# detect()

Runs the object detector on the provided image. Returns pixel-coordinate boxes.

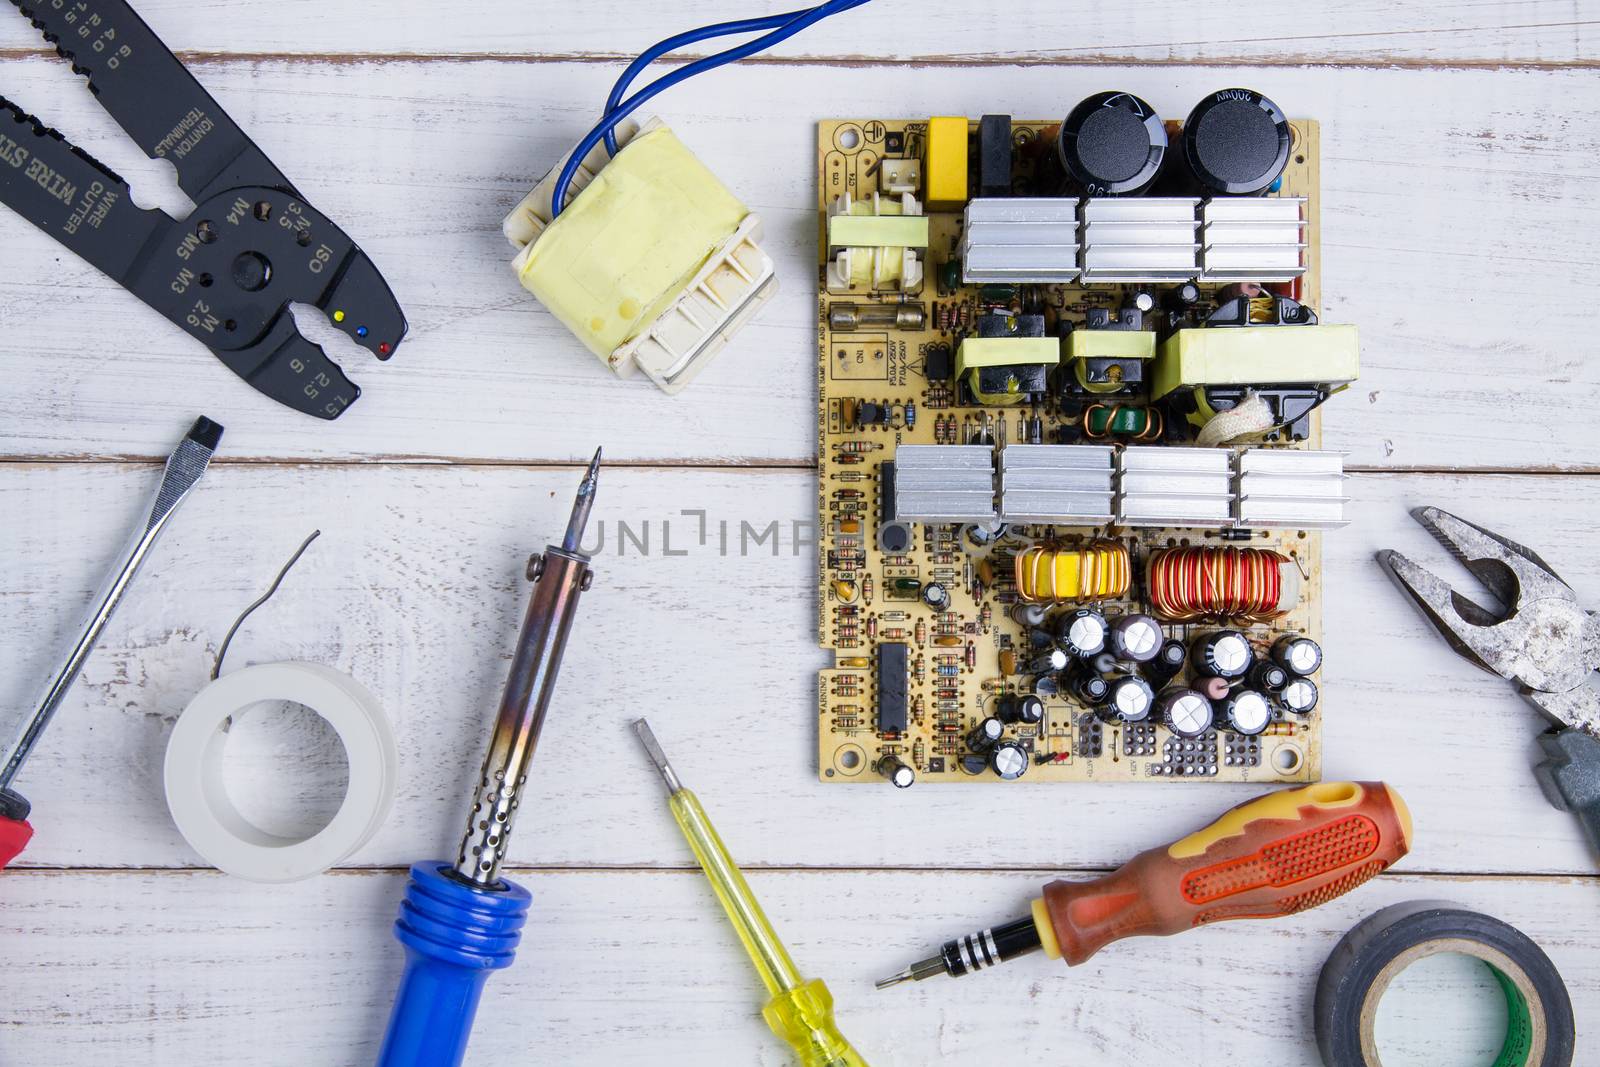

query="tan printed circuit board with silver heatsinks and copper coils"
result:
[818,103,1354,785]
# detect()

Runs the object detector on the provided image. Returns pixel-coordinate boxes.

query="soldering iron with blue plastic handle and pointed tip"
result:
[378,448,600,1067]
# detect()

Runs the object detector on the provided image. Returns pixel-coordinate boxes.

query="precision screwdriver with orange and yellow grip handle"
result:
[877,782,1411,989]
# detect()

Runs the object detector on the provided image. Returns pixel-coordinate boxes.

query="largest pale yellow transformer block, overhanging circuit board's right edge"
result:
[1152,323,1362,400]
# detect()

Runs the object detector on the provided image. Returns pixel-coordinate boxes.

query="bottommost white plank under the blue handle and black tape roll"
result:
[0,870,1600,1067]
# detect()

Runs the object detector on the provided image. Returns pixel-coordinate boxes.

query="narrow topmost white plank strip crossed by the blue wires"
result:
[0,0,1600,66]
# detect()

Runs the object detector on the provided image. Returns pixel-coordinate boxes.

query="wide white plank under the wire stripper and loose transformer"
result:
[0,59,1600,470]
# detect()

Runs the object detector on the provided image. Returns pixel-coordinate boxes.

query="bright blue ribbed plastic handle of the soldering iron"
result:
[378,859,533,1067]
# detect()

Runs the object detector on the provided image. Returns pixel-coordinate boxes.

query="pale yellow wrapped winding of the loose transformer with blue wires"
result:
[512,126,750,363]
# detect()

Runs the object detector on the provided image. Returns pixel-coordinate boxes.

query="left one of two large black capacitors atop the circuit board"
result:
[1053,93,1166,197]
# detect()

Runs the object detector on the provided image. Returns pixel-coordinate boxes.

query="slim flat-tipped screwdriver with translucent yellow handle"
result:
[634,718,867,1067]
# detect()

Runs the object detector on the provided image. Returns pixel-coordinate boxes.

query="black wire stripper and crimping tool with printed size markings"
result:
[0,0,406,419]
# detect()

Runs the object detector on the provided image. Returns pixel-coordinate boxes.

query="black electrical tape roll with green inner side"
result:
[1315,901,1576,1067]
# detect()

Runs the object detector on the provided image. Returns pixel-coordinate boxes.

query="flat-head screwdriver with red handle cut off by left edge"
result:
[0,416,222,867]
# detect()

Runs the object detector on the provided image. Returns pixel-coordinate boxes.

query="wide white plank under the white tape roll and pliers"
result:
[0,464,1600,873]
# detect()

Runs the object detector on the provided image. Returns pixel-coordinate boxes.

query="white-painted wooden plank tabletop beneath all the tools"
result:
[0,0,1600,1067]
